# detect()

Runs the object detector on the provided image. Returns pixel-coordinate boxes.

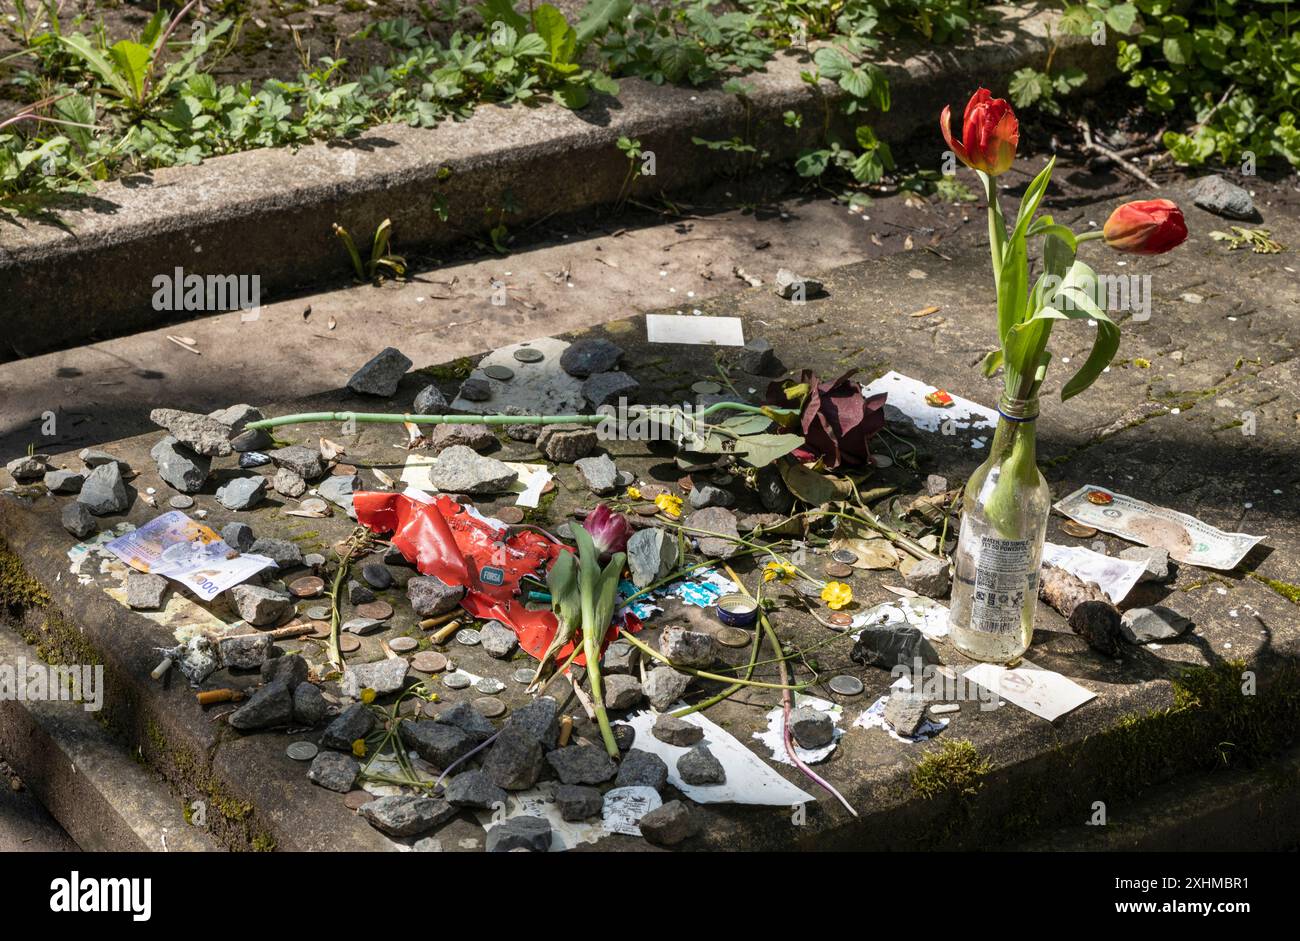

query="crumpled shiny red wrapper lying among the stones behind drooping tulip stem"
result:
[352,491,641,664]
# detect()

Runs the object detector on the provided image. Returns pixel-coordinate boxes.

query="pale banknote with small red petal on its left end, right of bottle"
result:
[1054,485,1264,569]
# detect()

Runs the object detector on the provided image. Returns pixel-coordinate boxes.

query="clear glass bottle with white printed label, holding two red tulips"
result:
[949,395,1052,663]
